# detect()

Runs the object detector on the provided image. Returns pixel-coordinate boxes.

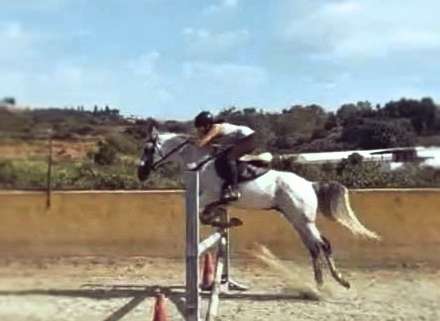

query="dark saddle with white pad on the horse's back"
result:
[215,153,273,183]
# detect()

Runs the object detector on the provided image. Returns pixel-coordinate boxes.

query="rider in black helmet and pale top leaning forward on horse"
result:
[194,111,256,201]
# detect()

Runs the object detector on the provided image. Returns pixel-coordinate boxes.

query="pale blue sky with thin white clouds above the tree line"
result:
[0,0,440,120]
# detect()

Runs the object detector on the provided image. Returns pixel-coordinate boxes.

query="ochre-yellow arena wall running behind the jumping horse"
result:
[0,189,440,266]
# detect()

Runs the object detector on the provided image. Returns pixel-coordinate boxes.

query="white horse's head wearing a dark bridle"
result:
[138,127,189,181]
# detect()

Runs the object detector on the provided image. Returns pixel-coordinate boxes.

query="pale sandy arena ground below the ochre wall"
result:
[0,257,440,321]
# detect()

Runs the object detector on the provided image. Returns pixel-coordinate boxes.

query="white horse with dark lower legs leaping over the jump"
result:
[138,129,379,288]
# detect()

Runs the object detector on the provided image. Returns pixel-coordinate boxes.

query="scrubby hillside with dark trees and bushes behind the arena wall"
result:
[0,98,440,189]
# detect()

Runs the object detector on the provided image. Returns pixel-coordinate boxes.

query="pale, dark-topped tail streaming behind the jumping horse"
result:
[313,182,380,240]
